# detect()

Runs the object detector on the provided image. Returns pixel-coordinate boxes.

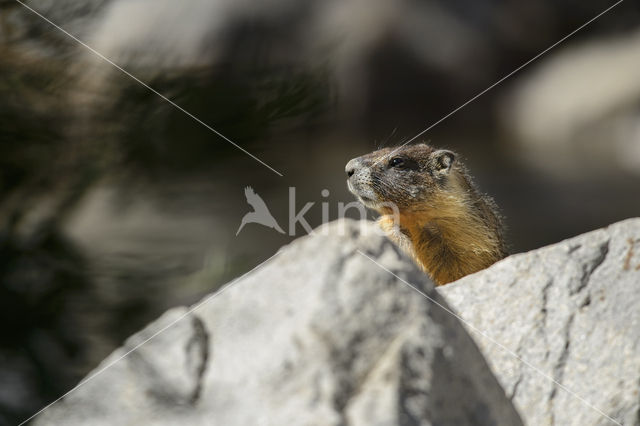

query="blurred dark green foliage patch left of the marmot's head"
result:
[109,62,333,174]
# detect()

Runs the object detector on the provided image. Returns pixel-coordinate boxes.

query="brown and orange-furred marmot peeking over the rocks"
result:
[345,144,507,285]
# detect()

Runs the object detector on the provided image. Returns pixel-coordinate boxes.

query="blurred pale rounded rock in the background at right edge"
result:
[503,31,640,178]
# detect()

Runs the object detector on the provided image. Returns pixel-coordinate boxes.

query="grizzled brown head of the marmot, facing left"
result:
[345,144,457,214]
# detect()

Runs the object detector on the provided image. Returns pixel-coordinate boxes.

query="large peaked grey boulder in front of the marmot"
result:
[36,221,521,425]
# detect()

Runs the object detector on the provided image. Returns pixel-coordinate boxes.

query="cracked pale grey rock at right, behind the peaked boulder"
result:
[439,219,640,425]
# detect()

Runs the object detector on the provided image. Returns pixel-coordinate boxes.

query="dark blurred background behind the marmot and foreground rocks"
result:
[0,0,640,424]
